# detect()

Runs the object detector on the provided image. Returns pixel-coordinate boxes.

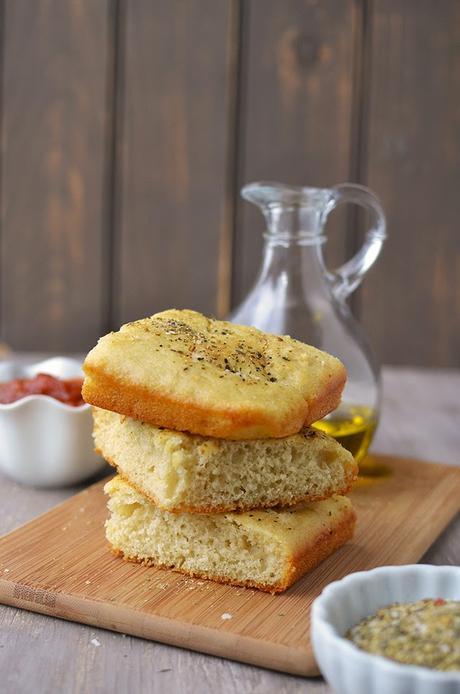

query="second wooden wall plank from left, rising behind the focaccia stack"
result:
[114,0,236,324]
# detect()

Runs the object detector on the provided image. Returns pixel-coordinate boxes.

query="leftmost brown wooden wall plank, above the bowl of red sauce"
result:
[0,0,112,351]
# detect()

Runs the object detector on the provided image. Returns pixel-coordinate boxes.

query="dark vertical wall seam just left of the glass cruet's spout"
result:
[229,0,250,309]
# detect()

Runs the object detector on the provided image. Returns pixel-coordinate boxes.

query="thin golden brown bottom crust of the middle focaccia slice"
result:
[102,448,356,515]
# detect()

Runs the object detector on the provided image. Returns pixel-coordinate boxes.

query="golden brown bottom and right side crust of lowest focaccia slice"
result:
[109,509,356,594]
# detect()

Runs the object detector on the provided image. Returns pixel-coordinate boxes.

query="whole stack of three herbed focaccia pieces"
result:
[83,310,357,593]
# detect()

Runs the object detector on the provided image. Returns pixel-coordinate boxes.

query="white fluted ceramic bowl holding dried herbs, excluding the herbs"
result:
[311,564,460,694]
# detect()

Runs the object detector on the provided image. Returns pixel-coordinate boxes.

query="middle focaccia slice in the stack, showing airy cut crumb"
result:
[93,408,358,513]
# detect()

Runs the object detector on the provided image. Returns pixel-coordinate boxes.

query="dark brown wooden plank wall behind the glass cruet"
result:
[0,0,460,366]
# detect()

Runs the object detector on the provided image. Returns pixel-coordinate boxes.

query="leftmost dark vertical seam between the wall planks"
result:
[102,0,126,333]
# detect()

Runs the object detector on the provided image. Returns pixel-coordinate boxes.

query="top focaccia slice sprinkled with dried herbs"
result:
[82,309,346,439]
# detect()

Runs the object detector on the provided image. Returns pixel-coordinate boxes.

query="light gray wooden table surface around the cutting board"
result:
[0,367,460,694]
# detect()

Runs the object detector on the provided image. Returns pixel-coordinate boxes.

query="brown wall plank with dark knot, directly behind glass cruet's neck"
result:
[233,0,360,303]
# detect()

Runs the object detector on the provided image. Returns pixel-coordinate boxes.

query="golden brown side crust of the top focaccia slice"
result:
[82,364,346,440]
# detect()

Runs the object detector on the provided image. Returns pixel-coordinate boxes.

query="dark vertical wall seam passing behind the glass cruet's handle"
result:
[346,0,372,318]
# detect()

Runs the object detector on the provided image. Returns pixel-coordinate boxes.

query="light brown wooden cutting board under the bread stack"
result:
[0,457,460,675]
